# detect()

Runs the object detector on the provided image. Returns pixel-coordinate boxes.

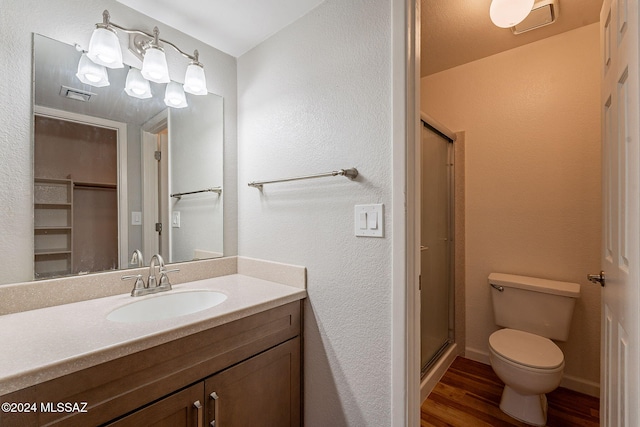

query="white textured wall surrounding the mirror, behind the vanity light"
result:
[0,0,237,283]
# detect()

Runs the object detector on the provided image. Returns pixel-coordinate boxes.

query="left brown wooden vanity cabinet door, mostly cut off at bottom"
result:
[108,382,205,427]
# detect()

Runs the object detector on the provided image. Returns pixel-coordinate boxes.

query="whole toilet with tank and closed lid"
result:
[489,273,580,426]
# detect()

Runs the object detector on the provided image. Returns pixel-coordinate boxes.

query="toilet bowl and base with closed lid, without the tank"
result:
[489,329,564,426]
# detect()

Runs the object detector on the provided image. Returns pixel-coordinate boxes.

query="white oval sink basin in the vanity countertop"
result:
[107,290,227,323]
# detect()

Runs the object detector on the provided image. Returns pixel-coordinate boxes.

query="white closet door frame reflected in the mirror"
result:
[33,105,129,269]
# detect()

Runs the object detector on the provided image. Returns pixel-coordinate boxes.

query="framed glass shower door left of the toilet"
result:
[420,115,455,376]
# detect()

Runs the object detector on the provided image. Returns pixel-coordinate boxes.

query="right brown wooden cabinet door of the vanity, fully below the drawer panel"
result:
[205,337,300,427]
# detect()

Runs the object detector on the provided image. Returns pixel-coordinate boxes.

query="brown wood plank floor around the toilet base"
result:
[420,357,600,427]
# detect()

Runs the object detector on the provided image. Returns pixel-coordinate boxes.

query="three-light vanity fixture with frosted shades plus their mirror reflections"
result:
[76,10,208,108]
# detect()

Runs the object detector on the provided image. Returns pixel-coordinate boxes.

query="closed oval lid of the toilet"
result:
[489,329,564,369]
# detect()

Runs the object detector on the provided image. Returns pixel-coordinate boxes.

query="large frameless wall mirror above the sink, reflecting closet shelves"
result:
[33,34,224,279]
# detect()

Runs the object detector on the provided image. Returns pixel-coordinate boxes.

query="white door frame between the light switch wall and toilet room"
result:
[391,0,422,427]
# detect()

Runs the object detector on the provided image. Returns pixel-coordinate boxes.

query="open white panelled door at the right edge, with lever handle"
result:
[600,0,640,427]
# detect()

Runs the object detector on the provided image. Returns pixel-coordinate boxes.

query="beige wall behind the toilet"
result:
[421,24,601,394]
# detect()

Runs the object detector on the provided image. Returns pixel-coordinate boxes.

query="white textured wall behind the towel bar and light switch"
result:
[238,0,392,427]
